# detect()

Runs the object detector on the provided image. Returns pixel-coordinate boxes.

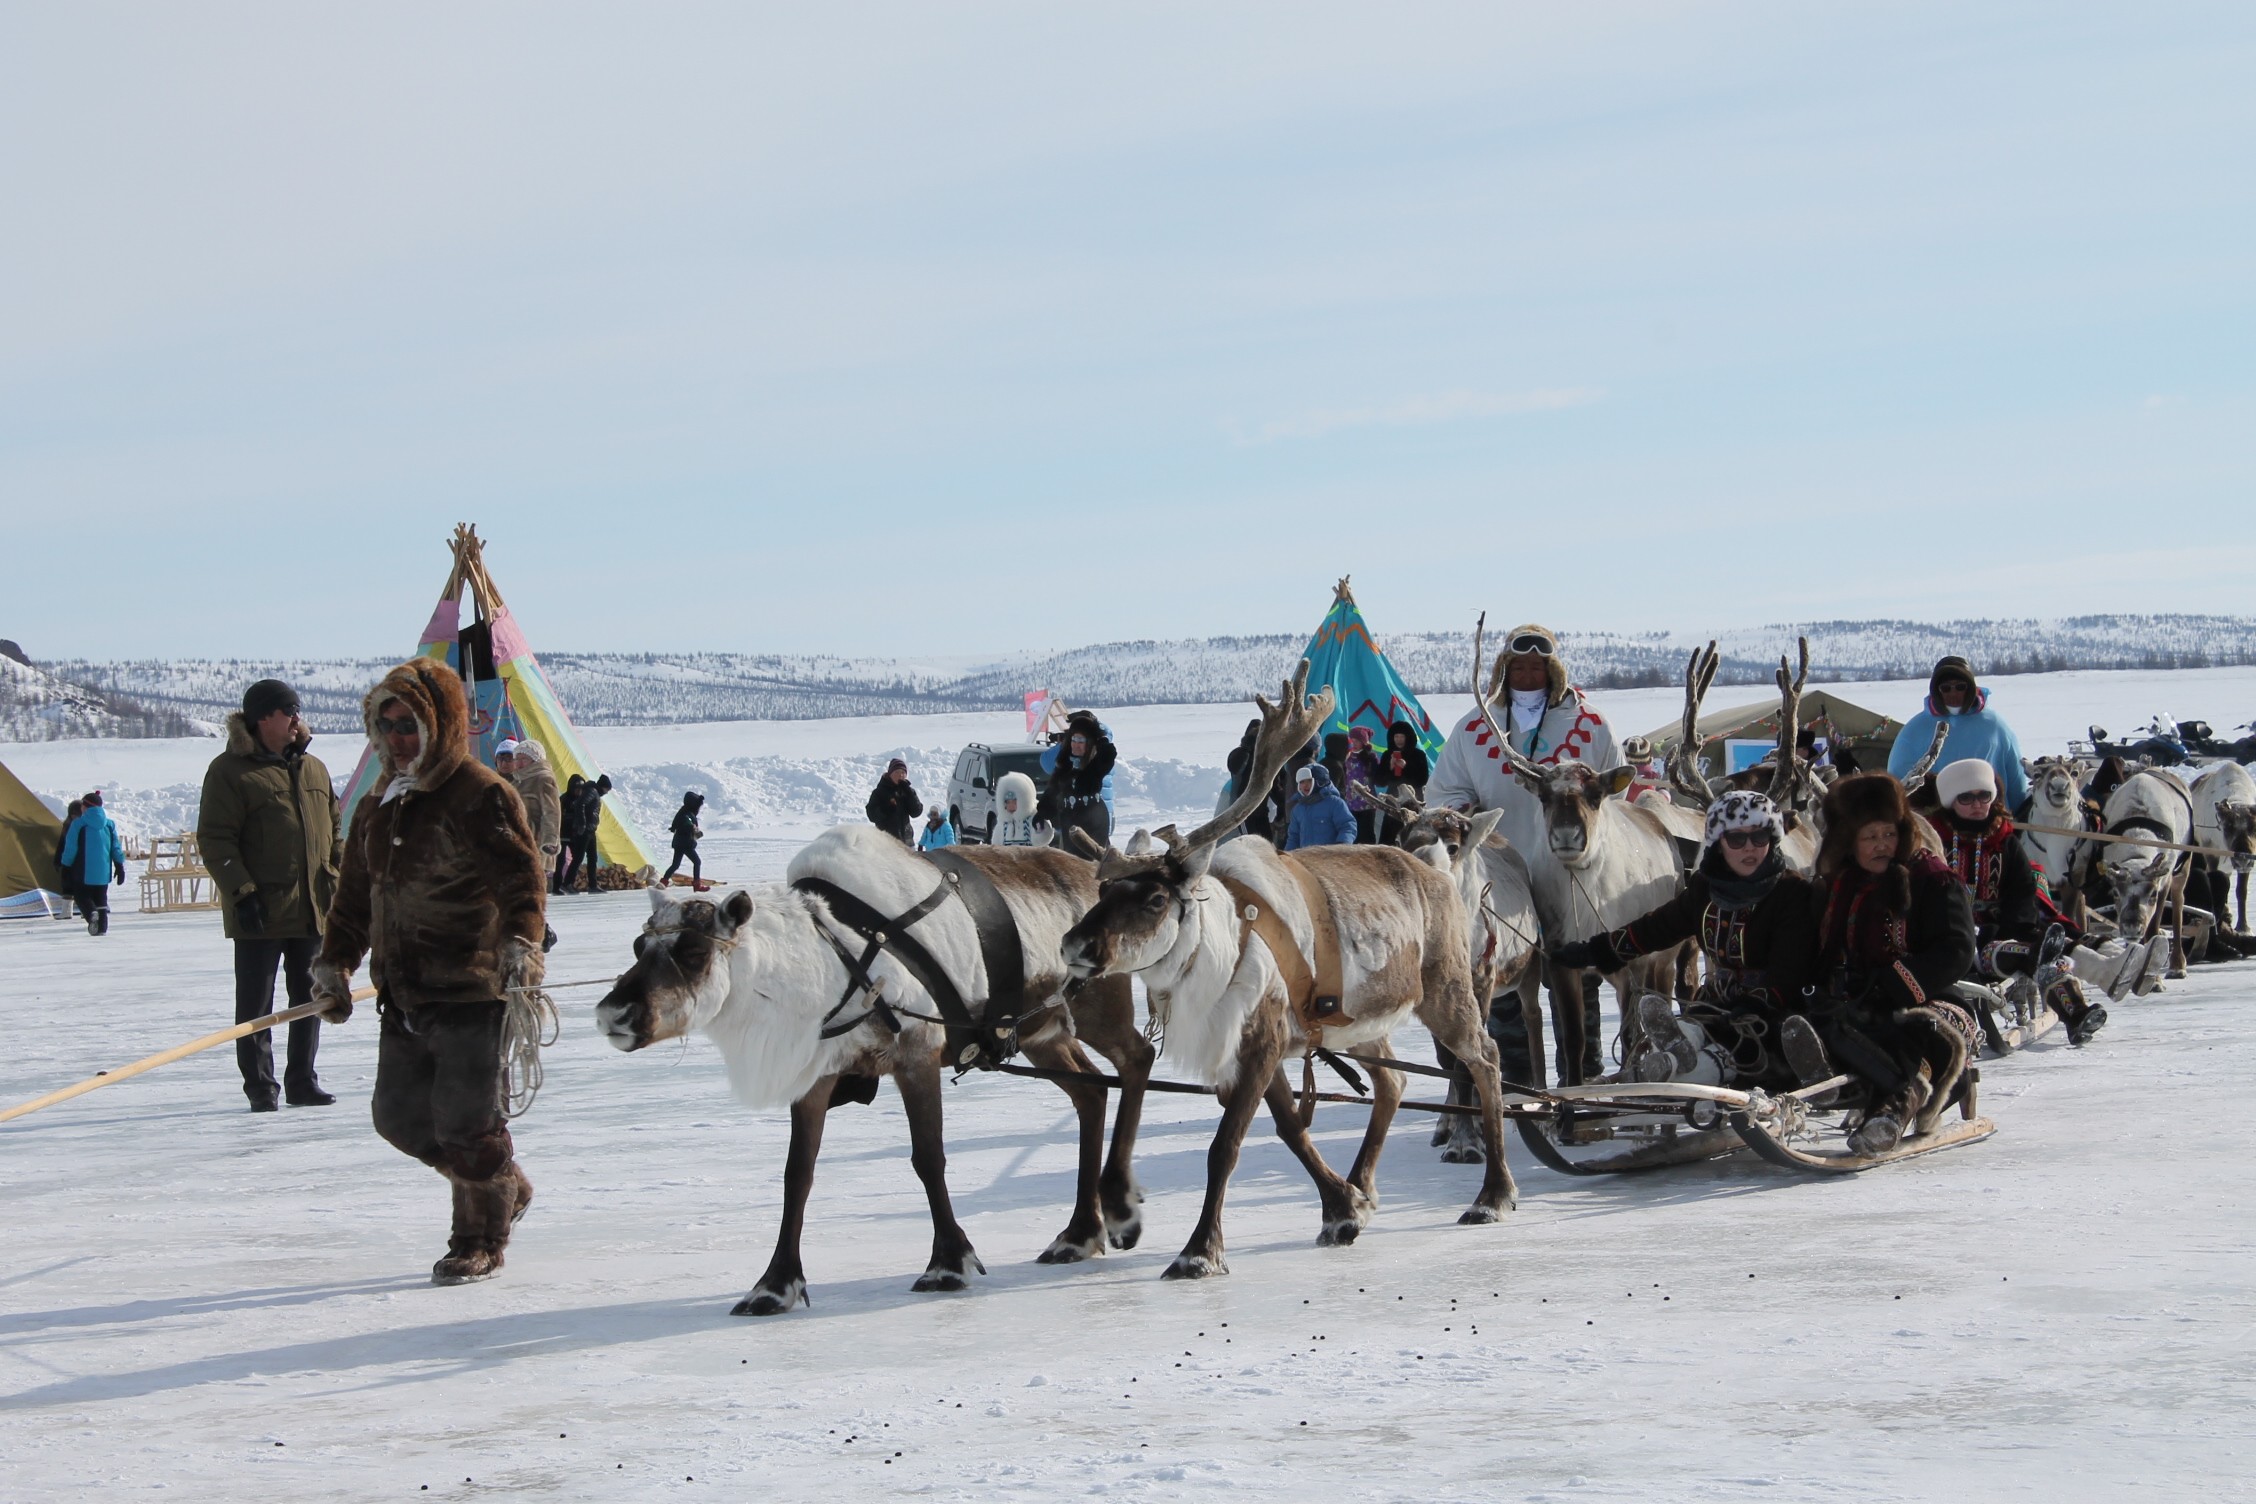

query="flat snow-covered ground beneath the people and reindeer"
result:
[13,670,2256,1504]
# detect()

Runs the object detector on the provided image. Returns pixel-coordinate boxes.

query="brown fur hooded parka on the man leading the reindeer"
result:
[320,658,548,1008]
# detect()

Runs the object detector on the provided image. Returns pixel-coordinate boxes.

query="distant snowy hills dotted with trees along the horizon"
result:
[47,616,2256,735]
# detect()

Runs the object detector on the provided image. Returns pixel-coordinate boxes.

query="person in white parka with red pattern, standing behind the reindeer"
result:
[1426,622,1622,1080]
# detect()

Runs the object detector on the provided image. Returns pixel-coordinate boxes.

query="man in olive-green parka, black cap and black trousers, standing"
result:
[196,679,338,1112]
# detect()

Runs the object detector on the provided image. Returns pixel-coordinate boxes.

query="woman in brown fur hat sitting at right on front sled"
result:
[1812,773,1976,1154]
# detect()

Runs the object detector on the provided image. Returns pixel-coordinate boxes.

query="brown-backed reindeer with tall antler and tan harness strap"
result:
[1063,661,1516,1279]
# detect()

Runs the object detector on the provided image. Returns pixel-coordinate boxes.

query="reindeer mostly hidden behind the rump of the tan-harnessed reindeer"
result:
[1356,782,1543,1164]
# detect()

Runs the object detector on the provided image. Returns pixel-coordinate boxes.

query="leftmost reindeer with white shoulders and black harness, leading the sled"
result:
[596,834,1155,1317]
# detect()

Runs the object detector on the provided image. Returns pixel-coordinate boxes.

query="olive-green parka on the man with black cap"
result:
[196,713,341,940]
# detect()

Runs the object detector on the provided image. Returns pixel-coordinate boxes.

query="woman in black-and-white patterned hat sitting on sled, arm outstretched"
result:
[1550,791,1832,1087]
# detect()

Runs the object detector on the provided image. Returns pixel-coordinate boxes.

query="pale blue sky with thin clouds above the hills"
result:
[0,0,2256,658]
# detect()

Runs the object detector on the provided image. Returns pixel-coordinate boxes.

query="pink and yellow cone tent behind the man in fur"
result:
[345,523,654,873]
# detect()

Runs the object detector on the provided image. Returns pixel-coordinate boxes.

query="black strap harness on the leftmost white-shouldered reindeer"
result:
[792,848,1026,1071]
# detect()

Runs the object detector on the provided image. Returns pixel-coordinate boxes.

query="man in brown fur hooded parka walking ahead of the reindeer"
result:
[314,658,548,1285]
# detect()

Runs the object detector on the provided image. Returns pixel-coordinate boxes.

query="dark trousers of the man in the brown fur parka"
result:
[372,999,514,1182]
